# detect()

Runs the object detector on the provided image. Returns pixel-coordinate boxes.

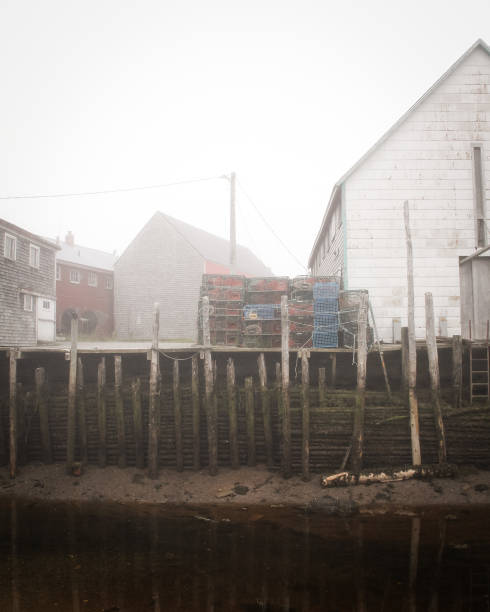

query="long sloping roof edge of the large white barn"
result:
[308,38,490,268]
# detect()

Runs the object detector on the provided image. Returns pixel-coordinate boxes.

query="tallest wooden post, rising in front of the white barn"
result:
[403,200,422,465]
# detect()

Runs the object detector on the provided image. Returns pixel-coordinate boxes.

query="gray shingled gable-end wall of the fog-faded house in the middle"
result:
[114,215,204,340]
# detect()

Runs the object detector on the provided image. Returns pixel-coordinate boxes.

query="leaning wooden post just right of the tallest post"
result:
[425,292,447,463]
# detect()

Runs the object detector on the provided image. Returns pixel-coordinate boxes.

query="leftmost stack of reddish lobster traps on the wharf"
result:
[199,274,245,346]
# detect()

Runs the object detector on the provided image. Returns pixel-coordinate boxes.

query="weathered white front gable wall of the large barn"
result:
[345,47,490,341]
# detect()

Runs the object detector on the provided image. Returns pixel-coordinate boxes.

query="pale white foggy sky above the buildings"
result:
[0,0,490,275]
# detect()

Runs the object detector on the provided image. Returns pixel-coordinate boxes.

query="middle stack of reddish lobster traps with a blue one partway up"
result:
[243,276,289,348]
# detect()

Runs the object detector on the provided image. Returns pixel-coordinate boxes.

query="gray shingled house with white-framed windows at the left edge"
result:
[0,219,59,346]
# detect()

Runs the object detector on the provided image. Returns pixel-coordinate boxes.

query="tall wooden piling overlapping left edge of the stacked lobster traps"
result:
[202,295,218,476]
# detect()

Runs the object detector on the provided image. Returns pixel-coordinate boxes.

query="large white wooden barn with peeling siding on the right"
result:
[309,40,490,342]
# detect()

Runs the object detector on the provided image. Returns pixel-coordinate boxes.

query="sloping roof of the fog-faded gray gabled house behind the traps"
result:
[130,212,272,276]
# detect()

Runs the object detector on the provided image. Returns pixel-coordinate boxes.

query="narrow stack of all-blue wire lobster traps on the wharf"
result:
[313,279,340,348]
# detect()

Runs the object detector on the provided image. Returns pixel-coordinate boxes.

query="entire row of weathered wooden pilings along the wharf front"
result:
[4,278,462,480]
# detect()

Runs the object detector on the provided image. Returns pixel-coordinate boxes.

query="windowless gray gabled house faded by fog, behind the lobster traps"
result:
[114,212,272,340]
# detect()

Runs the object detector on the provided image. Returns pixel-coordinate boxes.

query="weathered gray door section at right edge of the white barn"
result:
[459,255,490,340]
